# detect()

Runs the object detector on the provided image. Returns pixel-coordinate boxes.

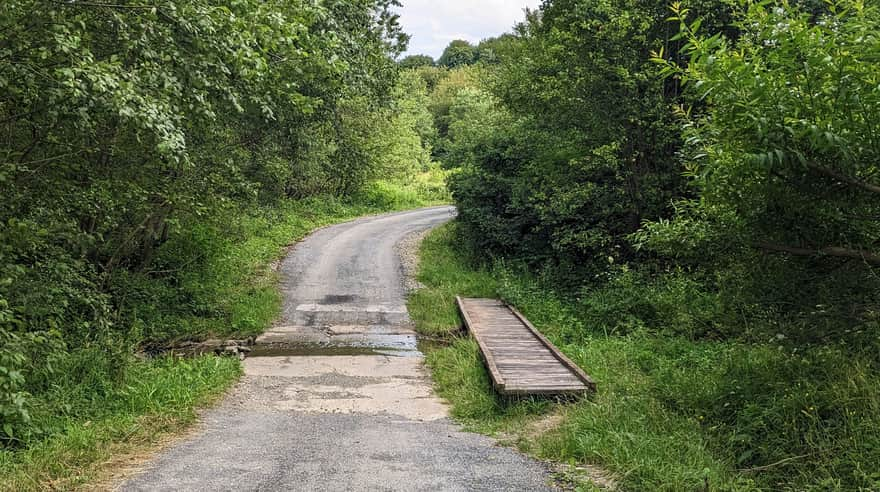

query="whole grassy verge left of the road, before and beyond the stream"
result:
[0,176,448,491]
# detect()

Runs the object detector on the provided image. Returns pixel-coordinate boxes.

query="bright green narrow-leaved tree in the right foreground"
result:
[633,1,880,338]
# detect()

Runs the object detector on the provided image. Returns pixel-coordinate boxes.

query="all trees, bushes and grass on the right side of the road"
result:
[432,0,880,490]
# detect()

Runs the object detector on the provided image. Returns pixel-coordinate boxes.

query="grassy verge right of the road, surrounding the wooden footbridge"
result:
[409,224,880,491]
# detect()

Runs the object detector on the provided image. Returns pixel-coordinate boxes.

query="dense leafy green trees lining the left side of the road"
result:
[0,0,406,443]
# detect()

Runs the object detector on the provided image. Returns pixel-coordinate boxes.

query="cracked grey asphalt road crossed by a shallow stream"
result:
[120,207,551,491]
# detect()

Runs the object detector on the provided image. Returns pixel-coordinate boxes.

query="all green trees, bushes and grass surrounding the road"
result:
[0,0,880,491]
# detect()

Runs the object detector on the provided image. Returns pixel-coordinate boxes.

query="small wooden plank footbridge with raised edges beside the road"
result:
[456,297,596,395]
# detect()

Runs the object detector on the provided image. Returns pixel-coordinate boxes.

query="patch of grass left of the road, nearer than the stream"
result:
[0,356,241,491]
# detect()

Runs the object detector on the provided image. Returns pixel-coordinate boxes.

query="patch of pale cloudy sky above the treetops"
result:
[398,0,541,60]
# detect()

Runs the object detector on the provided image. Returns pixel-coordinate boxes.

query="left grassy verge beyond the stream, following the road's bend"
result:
[112,183,447,343]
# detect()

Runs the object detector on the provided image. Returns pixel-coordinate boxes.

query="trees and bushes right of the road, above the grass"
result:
[440,0,880,338]
